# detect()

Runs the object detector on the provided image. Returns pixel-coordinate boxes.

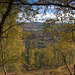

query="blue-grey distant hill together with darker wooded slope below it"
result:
[22,22,56,48]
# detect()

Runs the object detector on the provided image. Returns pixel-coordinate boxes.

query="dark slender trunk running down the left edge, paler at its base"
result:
[0,0,14,75]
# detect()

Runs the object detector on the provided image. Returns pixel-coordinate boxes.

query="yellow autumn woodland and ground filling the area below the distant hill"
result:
[0,21,75,75]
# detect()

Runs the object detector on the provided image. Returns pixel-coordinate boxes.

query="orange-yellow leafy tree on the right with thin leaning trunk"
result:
[44,20,74,75]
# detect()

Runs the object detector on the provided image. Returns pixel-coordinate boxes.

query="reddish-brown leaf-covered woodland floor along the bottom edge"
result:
[0,64,74,75]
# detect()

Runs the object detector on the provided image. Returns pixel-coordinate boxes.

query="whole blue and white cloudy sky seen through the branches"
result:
[18,0,75,22]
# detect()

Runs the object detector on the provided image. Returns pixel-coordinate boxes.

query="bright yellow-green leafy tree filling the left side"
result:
[0,22,24,72]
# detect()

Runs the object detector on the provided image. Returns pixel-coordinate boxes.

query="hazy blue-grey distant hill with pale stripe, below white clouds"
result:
[22,22,43,32]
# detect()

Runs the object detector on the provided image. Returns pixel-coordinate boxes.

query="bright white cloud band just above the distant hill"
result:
[19,9,75,22]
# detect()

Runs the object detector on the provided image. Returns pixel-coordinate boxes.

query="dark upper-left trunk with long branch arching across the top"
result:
[0,0,75,36]
